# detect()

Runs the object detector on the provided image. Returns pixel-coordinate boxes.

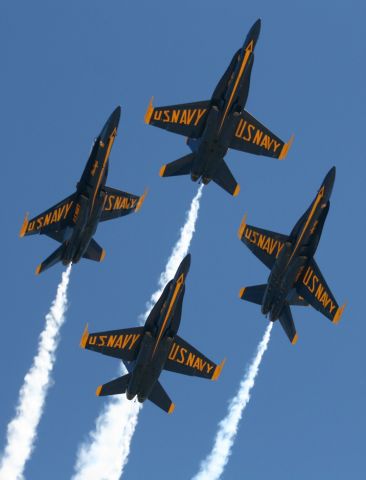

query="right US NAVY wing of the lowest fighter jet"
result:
[164,335,225,380]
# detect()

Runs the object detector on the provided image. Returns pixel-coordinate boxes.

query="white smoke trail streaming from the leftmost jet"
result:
[0,264,71,480]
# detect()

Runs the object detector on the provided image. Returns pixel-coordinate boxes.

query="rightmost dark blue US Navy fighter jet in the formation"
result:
[238,167,345,344]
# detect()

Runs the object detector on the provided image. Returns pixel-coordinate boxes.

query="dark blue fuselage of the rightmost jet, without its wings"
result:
[262,168,335,321]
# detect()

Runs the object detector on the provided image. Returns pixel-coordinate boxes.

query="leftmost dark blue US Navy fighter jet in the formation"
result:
[20,107,146,275]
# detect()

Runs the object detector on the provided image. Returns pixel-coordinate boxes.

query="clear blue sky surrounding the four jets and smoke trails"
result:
[0,0,366,480]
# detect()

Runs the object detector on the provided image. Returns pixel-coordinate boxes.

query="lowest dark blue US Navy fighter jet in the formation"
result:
[80,254,224,413]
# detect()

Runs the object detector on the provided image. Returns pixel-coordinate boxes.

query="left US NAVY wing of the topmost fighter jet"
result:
[145,99,211,138]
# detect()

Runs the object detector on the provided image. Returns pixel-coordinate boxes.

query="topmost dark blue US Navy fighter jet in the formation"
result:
[145,20,293,196]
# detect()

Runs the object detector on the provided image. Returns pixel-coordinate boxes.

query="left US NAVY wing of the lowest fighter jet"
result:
[80,326,144,362]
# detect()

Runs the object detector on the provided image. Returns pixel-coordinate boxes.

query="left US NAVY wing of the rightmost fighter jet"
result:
[238,215,288,270]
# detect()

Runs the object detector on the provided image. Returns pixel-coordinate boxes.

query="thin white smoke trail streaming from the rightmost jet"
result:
[192,322,273,480]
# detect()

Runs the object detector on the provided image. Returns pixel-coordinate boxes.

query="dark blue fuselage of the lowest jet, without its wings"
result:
[126,255,190,402]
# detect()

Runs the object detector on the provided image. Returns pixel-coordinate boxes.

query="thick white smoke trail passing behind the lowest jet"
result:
[72,185,203,480]
